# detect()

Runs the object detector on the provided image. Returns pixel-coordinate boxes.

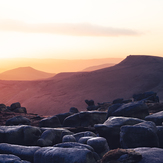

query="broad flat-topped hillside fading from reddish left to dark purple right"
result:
[0,56,163,115]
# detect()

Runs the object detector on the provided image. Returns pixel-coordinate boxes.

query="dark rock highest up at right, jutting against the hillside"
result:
[132,91,159,102]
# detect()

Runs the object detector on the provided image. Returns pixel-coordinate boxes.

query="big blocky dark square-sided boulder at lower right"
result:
[120,121,159,148]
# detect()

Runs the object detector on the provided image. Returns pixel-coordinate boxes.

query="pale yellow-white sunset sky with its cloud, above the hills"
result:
[0,0,163,59]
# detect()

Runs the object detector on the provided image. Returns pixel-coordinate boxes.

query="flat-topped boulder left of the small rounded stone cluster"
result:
[37,128,72,147]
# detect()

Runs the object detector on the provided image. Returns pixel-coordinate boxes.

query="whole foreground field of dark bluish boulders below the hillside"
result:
[0,92,163,163]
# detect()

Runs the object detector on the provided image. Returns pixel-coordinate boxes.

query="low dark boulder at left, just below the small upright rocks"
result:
[6,116,31,126]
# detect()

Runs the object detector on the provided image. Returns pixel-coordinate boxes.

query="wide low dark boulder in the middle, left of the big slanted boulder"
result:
[63,111,106,127]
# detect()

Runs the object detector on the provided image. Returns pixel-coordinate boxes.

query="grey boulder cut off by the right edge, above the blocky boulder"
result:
[145,111,163,126]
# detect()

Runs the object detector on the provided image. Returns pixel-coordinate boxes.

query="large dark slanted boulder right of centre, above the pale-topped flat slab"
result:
[107,101,149,119]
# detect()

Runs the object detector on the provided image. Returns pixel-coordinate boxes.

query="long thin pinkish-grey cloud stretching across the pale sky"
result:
[0,19,140,37]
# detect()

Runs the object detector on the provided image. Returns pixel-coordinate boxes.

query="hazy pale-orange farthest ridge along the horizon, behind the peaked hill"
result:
[0,58,123,73]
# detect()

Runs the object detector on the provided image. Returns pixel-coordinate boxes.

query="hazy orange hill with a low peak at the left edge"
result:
[0,67,55,80]
